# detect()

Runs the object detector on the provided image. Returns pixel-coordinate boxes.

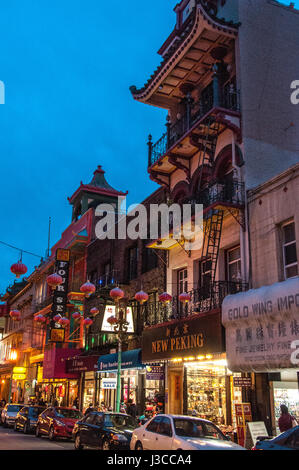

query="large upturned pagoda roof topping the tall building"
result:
[130,0,240,108]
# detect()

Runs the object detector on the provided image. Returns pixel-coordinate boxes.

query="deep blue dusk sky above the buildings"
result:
[0,0,299,293]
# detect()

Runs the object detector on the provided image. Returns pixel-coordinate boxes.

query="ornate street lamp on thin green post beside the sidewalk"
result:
[108,288,129,413]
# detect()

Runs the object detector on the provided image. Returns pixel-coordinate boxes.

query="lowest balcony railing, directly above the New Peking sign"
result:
[143,281,249,326]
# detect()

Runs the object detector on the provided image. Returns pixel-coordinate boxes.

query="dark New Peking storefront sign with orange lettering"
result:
[142,314,224,362]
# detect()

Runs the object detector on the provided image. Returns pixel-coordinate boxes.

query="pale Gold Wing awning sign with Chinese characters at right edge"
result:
[222,277,299,372]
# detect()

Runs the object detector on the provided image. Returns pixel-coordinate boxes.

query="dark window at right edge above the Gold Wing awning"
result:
[282,222,298,279]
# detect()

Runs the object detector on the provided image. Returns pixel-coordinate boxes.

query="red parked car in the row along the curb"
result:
[35,406,82,441]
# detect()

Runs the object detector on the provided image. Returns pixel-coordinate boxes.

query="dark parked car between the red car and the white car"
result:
[73,412,138,450]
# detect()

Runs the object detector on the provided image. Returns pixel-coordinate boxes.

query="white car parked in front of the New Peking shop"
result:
[130,414,246,450]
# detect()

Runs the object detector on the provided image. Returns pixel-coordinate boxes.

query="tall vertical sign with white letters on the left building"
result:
[49,248,70,342]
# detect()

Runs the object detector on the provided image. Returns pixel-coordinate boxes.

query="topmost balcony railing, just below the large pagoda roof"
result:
[148,88,240,166]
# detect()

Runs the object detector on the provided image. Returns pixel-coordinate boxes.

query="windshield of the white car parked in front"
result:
[173,418,225,440]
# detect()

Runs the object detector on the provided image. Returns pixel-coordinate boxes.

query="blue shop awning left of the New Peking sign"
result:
[98,349,145,373]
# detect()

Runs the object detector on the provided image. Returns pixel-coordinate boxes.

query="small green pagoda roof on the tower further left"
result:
[68,165,128,204]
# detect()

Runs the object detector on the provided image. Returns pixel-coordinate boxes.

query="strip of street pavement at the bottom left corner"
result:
[0,426,74,450]
